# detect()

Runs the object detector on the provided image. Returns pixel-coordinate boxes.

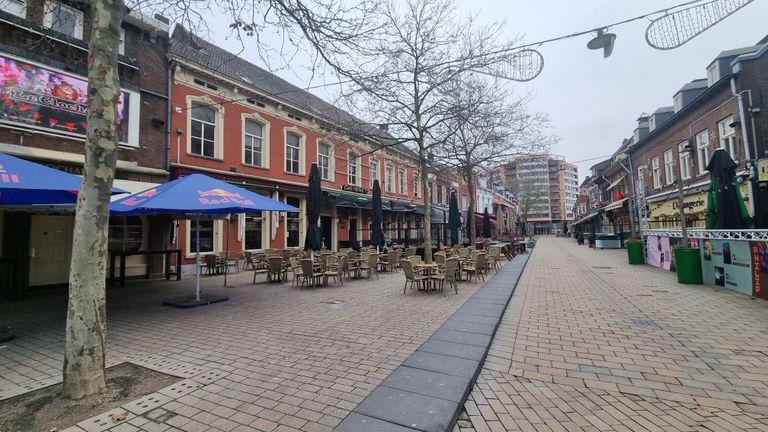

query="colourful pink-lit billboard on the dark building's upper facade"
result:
[0,55,130,142]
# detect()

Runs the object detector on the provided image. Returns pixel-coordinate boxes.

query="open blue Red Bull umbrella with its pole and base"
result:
[109,174,299,304]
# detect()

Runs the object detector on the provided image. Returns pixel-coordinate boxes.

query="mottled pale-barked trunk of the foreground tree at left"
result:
[62,0,127,399]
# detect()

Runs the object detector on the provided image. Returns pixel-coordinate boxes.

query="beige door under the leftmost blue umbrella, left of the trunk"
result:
[29,215,75,286]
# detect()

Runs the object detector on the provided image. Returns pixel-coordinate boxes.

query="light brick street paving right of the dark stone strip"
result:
[454,237,768,432]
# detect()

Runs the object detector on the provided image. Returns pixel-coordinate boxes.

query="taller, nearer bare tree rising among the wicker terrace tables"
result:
[340,0,512,262]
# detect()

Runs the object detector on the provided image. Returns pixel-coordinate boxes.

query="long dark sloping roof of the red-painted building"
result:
[170,24,414,156]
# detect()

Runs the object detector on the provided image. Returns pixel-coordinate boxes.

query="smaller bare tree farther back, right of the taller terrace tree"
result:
[440,74,556,241]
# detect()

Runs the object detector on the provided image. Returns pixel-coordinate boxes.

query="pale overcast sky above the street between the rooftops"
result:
[207,0,768,179]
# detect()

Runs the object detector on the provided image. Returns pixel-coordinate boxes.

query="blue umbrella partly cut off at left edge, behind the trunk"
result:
[0,154,125,205]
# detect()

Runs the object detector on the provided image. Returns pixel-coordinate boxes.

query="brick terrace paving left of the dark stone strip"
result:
[0,264,488,432]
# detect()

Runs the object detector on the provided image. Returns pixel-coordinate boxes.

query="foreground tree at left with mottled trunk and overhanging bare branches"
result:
[62,0,375,399]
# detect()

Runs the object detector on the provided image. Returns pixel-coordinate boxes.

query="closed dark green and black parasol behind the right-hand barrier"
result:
[706,149,750,229]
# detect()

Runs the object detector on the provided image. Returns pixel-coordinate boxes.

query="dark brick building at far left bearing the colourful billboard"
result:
[0,0,168,297]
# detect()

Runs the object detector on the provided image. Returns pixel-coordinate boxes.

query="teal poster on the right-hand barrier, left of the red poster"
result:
[699,239,754,295]
